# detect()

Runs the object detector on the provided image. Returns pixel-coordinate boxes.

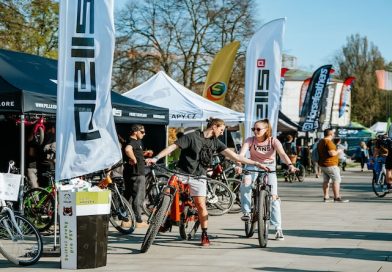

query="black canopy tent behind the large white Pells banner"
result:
[0,49,169,173]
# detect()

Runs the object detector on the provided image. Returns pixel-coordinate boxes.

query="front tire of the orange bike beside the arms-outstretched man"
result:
[140,194,171,253]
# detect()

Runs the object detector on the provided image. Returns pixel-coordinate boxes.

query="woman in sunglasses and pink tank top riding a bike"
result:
[238,119,296,240]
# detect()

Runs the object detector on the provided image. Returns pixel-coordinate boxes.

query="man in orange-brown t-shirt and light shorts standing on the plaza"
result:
[317,129,349,203]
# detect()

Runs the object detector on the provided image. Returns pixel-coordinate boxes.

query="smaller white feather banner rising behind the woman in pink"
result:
[245,18,286,138]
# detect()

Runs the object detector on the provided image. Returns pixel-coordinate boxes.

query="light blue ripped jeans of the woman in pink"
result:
[240,165,282,229]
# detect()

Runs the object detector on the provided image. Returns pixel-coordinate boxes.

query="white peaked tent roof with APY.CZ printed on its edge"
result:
[123,71,244,126]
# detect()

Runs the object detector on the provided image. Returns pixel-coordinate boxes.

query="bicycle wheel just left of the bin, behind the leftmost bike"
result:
[23,187,55,232]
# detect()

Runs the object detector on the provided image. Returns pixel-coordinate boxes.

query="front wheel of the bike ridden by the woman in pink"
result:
[257,190,270,248]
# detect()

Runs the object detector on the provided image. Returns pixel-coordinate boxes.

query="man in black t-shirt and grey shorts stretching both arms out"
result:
[146,118,266,246]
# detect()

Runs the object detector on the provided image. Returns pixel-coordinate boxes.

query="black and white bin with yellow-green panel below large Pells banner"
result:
[59,190,110,269]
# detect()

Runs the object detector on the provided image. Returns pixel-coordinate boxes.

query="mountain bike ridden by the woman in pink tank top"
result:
[244,169,275,248]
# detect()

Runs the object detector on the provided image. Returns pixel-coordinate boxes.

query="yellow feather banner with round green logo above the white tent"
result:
[203,41,240,105]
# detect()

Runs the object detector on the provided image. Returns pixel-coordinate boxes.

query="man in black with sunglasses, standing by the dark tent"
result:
[122,124,147,228]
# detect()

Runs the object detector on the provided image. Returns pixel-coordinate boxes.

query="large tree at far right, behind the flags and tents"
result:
[335,34,386,126]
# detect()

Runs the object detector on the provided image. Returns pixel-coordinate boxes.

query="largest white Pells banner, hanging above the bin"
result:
[56,0,121,181]
